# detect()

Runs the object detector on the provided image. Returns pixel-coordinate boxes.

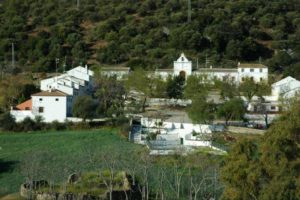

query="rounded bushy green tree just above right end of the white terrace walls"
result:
[217,98,246,125]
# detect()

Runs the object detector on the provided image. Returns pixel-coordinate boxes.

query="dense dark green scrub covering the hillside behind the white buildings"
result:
[0,0,300,78]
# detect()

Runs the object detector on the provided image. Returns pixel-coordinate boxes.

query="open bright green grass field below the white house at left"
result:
[0,129,141,196]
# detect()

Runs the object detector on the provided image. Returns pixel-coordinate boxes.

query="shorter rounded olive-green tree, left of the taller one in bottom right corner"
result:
[221,140,261,200]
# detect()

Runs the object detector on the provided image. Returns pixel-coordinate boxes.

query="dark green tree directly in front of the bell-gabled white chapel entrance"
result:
[167,75,185,99]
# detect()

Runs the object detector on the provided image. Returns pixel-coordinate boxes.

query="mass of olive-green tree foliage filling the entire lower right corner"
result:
[221,97,300,200]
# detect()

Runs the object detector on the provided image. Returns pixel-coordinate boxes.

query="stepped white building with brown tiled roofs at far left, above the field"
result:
[10,66,93,122]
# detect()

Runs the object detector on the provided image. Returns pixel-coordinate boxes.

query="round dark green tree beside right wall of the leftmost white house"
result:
[73,96,97,121]
